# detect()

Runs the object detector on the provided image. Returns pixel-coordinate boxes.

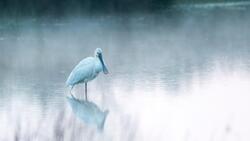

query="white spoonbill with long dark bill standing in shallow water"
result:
[66,48,109,100]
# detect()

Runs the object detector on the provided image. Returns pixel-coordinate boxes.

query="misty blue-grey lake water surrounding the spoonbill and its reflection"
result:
[0,4,250,141]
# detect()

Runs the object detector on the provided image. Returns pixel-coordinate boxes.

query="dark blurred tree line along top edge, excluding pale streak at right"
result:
[0,0,240,16]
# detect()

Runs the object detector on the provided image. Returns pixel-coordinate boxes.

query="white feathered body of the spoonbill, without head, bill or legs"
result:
[66,57,102,86]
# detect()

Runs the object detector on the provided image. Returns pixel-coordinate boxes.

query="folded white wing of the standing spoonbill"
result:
[66,57,95,85]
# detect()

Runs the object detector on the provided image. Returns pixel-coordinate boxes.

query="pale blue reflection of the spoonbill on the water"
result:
[67,95,108,130]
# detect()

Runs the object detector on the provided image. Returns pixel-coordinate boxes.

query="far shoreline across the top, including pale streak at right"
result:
[0,0,250,17]
